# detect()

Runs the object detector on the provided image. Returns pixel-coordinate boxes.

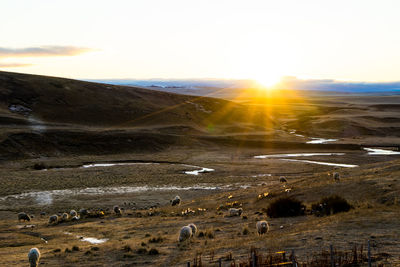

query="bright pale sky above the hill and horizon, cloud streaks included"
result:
[0,0,400,85]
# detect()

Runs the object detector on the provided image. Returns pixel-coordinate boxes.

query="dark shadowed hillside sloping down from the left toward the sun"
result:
[0,72,271,158]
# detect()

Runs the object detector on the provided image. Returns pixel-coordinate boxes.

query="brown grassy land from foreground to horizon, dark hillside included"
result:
[0,73,400,266]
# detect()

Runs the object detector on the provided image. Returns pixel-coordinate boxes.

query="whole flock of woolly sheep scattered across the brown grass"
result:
[18,175,340,267]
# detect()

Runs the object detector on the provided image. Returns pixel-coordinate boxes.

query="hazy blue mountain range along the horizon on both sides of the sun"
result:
[88,77,400,98]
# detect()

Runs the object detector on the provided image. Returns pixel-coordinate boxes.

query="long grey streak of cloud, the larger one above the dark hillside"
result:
[0,46,92,58]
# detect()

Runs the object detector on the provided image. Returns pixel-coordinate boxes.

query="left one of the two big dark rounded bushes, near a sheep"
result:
[267,197,306,218]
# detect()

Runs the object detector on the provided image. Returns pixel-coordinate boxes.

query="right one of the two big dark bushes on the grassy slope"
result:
[311,195,352,216]
